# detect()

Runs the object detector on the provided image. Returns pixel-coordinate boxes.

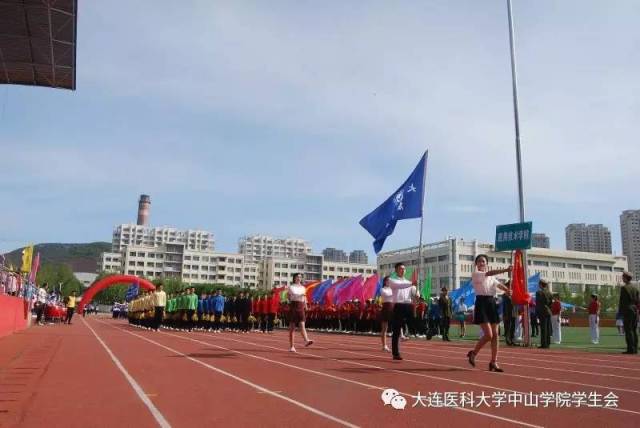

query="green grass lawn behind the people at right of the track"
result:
[450,323,627,354]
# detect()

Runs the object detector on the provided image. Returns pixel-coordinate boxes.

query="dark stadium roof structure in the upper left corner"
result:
[0,0,78,90]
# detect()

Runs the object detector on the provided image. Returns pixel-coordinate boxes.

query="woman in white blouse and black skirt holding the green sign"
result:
[467,254,512,372]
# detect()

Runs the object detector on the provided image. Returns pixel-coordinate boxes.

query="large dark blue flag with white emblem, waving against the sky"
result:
[360,152,428,254]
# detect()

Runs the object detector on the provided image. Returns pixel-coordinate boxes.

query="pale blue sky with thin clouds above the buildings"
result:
[0,0,640,256]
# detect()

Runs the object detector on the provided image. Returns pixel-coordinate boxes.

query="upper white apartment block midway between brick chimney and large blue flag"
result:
[238,235,311,262]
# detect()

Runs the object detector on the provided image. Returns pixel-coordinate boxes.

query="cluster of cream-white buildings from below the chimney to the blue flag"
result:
[98,225,376,289]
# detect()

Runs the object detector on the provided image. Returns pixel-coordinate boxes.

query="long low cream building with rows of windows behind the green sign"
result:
[378,238,627,294]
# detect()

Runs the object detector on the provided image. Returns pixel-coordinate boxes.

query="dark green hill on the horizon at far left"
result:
[5,242,111,272]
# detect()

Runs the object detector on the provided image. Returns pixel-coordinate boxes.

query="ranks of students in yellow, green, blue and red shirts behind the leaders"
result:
[127,286,460,340]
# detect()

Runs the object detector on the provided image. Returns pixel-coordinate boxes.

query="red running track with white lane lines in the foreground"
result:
[0,318,640,428]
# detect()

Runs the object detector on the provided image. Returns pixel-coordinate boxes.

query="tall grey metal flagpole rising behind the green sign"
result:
[507,0,531,346]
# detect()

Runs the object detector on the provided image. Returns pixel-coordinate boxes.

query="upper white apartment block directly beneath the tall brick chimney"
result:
[111,224,215,252]
